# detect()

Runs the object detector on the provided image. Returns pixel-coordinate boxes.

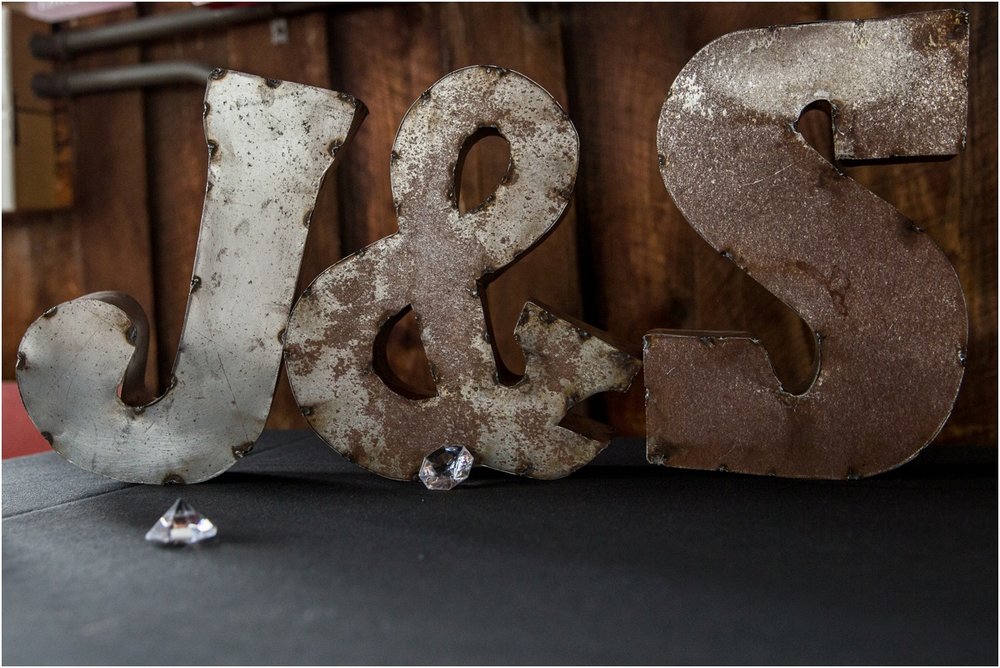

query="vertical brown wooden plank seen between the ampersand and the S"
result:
[565,4,697,434]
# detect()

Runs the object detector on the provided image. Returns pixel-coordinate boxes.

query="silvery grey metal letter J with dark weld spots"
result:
[17,70,364,483]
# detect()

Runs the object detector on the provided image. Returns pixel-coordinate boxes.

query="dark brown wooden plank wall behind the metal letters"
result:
[3,3,997,447]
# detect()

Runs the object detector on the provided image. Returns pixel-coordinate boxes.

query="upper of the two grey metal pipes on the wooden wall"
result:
[31,2,325,60]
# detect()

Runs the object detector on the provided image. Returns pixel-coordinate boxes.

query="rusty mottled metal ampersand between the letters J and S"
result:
[285,67,639,480]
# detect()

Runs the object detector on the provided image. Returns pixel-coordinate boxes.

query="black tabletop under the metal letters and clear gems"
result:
[3,432,997,665]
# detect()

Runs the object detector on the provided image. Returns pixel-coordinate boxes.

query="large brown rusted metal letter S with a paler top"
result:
[645,11,968,478]
